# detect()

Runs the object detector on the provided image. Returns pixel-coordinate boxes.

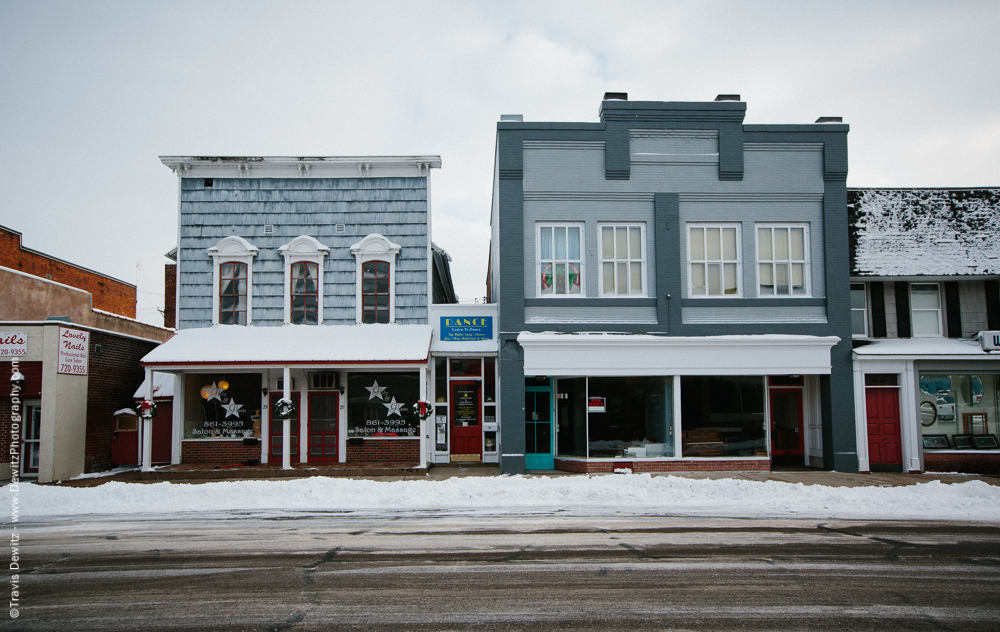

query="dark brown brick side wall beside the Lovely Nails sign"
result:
[83,331,157,472]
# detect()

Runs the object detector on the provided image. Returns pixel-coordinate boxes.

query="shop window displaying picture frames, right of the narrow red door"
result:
[917,373,1000,452]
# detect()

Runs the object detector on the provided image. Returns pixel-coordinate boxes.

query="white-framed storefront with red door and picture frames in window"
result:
[854,338,1000,474]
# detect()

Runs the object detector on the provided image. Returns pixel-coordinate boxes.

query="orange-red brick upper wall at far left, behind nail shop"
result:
[0,226,136,318]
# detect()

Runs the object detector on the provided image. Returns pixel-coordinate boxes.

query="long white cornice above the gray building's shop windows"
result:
[517,332,840,376]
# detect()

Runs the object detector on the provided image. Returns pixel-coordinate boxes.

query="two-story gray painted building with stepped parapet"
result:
[489,94,858,473]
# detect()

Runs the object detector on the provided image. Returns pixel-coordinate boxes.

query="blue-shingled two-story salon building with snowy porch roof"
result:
[143,156,500,466]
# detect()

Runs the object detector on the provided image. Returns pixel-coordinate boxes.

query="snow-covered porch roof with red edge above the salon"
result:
[142,325,432,368]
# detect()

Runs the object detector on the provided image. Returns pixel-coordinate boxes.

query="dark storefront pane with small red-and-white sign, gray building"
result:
[587,377,673,457]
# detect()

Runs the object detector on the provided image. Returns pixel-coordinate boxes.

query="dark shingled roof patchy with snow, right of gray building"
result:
[847,189,1000,276]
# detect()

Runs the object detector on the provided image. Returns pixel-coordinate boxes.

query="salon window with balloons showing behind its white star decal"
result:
[184,373,261,439]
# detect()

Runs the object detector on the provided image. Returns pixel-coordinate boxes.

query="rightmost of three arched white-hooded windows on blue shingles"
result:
[351,233,402,323]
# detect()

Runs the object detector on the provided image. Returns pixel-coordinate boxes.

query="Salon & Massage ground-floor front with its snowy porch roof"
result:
[143,325,433,467]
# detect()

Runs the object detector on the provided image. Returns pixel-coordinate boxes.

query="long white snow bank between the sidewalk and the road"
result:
[7,474,1000,523]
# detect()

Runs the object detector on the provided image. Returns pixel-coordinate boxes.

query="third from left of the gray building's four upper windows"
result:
[688,224,741,297]
